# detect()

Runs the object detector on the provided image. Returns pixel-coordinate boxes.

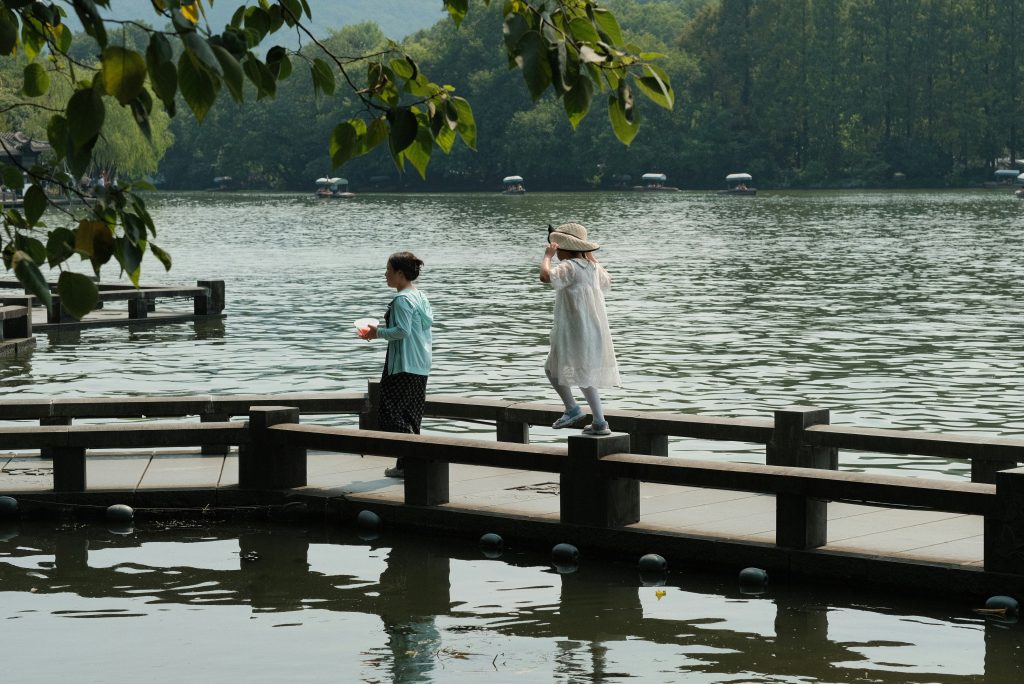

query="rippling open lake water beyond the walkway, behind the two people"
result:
[0,191,1024,477]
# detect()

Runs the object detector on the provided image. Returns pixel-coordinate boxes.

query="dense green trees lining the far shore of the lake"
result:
[160,0,1024,191]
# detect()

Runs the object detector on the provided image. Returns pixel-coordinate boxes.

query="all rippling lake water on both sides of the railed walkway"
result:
[0,191,1024,682]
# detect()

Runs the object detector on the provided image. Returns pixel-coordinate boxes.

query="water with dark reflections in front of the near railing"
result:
[0,525,1024,682]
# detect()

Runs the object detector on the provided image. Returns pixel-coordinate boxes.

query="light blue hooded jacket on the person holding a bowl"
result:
[377,288,434,375]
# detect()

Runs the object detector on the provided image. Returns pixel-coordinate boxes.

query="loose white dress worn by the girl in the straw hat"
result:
[545,259,620,387]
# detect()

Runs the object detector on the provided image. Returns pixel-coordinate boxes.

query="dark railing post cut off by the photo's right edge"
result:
[985,468,1024,575]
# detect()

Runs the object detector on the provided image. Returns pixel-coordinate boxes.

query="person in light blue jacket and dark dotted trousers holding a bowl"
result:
[359,252,434,477]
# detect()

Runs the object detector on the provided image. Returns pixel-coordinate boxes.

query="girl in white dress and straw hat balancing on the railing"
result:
[541,223,618,434]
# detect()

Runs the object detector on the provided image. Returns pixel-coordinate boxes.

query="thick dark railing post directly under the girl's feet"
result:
[559,434,640,527]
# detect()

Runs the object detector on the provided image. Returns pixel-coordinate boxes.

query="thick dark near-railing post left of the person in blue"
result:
[239,407,306,489]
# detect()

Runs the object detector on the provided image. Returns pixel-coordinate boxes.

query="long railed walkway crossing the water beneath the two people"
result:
[0,384,1024,596]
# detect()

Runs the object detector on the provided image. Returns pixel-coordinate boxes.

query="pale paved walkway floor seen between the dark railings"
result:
[0,451,984,569]
